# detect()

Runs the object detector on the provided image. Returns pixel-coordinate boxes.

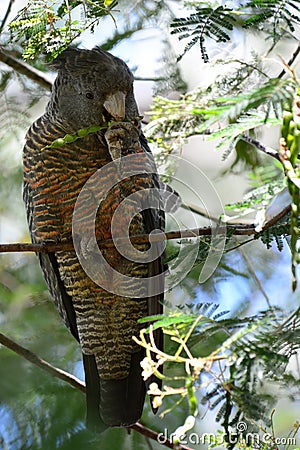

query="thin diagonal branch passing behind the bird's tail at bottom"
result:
[0,333,192,450]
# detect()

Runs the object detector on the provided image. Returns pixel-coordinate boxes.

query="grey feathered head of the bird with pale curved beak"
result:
[46,47,138,131]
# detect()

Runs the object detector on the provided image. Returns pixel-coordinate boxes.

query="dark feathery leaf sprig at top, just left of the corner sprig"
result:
[171,6,235,62]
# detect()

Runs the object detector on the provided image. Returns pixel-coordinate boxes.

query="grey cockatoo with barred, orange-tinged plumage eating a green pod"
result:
[24,48,164,430]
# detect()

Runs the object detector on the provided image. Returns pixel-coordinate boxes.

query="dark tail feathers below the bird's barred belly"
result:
[83,350,146,432]
